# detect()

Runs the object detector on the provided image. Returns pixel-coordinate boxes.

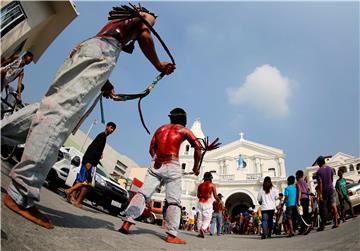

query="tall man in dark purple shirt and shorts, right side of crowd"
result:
[316,156,339,231]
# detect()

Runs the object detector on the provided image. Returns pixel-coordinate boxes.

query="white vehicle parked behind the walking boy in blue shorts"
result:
[65,159,129,216]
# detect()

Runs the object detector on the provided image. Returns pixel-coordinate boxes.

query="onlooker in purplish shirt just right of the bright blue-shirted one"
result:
[295,170,310,234]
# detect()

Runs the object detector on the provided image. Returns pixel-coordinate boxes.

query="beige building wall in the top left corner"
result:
[1,1,79,62]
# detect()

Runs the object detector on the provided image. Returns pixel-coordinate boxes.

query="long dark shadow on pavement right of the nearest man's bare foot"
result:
[37,205,114,229]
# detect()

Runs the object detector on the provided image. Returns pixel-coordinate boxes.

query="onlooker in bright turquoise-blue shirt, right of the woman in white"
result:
[284,175,297,237]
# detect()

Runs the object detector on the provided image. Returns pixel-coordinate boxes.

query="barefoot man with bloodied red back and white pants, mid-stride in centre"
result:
[119,108,201,244]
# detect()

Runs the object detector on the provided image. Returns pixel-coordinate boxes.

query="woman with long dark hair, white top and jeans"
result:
[257,176,278,239]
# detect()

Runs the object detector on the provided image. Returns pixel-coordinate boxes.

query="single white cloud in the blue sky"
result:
[227,65,290,118]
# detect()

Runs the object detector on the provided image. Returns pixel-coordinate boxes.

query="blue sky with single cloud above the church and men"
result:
[23,1,360,175]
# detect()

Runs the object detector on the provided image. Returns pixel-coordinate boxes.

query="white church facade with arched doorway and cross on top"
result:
[153,120,287,218]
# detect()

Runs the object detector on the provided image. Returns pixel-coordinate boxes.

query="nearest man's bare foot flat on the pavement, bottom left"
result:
[3,194,54,229]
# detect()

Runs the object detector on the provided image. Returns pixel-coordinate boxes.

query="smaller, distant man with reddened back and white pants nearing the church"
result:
[197,172,220,238]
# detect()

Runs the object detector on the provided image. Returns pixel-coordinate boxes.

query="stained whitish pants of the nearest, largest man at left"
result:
[1,38,121,208]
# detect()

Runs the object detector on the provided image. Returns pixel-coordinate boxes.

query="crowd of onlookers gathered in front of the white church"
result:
[174,156,356,239]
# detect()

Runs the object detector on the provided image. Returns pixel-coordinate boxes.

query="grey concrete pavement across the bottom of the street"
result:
[1,162,360,250]
